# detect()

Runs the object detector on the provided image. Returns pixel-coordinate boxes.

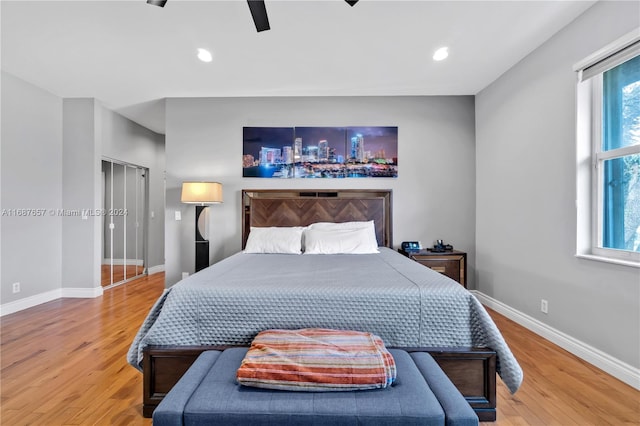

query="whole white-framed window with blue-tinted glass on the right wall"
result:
[575,31,640,266]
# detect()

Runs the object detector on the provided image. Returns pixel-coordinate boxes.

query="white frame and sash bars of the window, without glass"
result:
[574,28,640,268]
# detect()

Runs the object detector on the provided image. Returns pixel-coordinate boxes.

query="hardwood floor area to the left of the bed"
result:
[0,274,164,425]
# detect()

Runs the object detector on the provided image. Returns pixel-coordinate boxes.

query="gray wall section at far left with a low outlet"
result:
[0,72,62,303]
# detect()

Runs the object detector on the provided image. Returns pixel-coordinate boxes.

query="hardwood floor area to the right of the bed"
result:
[489,310,640,426]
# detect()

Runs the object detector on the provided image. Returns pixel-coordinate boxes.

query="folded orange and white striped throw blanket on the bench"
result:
[237,328,396,392]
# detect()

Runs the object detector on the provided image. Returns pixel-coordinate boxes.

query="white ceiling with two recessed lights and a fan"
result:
[0,0,595,133]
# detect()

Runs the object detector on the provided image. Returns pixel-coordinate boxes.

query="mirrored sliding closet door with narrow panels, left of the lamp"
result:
[101,159,148,287]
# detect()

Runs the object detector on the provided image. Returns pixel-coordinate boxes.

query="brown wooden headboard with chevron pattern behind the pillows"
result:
[242,189,393,249]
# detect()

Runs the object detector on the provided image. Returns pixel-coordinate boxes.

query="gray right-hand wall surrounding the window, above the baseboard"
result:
[476,2,640,368]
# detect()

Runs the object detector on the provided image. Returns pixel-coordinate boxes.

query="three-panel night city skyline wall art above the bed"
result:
[242,127,398,179]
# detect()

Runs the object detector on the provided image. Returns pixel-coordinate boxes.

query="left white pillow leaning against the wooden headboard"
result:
[244,226,304,254]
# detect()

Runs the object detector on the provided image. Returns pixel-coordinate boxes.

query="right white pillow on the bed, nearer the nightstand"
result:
[304,228,379,254]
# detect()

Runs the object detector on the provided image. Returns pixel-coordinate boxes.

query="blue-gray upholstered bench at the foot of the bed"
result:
[153,348,478,426]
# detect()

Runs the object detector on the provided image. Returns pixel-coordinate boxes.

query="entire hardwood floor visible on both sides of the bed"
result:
[0,274,640,426]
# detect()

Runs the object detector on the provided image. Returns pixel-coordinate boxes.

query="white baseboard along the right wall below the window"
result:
[472,290,640,390]
